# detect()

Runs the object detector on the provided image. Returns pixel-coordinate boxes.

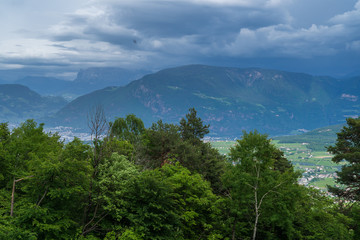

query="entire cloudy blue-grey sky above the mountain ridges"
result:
[0,0,360,79]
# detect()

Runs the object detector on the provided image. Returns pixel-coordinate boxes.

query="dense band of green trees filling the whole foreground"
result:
[0,107,360,240]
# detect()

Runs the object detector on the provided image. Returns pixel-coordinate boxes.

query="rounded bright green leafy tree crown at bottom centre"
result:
[118,164,216,239]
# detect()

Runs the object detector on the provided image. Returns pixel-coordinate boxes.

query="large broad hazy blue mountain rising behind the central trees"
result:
[52,65,359,136]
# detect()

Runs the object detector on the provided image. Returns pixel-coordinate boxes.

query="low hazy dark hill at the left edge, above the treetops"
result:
[0,84,67,123]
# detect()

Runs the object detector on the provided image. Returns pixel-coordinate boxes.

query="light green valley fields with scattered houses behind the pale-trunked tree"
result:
[211,137,341,191]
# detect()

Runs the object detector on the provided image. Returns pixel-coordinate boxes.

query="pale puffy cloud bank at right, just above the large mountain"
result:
[224,25,346,58]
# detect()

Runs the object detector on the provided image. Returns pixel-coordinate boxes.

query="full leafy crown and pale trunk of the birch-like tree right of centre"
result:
[223,131,298,239]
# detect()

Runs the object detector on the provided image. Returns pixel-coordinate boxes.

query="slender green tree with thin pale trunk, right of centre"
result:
[224,131,297,240]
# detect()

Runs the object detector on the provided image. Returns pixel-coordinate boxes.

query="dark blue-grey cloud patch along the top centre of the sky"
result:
[107,1,285,37]
